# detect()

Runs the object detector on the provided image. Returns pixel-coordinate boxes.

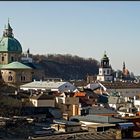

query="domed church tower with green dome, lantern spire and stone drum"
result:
[0,20,22,65]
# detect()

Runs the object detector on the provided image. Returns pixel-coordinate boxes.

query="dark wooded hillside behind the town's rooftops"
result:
[32,54,99,80]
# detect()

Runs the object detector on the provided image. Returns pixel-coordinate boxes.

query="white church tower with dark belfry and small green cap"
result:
[97,52,113,81]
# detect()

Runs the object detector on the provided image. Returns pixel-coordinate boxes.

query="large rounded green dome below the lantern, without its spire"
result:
[0,37,22,53]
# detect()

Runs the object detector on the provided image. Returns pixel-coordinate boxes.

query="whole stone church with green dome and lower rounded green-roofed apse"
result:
[0,21,44,85]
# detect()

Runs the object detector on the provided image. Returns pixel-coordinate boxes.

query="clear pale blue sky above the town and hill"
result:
[0,1,140,75]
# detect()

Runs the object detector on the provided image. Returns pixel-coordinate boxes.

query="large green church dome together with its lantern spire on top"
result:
[0,22,22,53]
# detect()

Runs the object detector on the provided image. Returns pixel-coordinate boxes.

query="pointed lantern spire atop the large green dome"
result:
[3,18,13,37]
